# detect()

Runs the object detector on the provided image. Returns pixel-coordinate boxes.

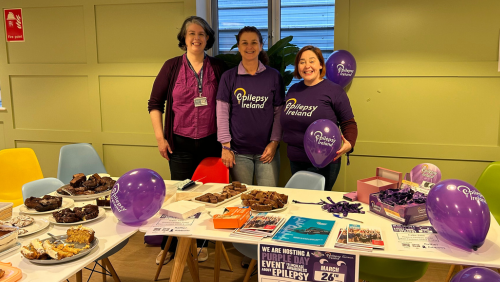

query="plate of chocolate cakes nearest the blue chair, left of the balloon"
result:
[56,173,116,201]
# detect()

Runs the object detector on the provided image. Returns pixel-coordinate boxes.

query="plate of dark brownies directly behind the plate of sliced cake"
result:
[49,204,106,225]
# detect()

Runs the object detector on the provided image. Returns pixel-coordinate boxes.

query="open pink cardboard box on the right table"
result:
[357,167,403,204]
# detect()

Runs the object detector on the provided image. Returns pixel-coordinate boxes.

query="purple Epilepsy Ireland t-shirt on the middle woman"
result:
[217,66,285,154]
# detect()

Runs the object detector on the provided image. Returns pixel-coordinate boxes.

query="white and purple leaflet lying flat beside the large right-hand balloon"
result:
[392,224,450,252]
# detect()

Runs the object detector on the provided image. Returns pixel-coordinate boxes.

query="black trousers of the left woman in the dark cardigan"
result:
[161,134,222,252]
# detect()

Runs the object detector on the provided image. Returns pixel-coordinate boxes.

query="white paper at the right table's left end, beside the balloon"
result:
[145,213,201,236]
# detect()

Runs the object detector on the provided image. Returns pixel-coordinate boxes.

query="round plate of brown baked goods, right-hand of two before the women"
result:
[241,190,288,211]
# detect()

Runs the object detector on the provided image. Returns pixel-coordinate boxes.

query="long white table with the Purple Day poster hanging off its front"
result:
[146,183,500,282]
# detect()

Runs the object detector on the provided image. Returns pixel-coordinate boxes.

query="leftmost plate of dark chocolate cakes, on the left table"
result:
[19,195,75,215]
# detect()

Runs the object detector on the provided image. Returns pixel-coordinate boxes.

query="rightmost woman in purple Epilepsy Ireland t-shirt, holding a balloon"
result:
[281,45,358,191]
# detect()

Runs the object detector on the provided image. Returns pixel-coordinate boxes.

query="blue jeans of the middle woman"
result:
[229,149,280,187]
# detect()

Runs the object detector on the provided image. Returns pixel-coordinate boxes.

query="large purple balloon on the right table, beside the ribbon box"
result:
[427,179,491,251]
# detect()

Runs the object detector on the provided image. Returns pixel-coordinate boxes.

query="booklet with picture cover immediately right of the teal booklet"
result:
[347,224,384,249]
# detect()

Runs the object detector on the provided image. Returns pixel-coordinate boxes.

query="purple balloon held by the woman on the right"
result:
[304,119,342,168]
